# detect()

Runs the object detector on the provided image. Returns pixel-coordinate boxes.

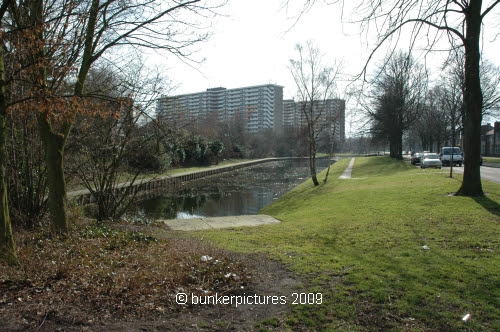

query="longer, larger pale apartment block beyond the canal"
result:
[157,84,283,133]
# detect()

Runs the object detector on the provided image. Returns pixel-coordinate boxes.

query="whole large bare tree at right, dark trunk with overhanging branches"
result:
[292,0,500,196]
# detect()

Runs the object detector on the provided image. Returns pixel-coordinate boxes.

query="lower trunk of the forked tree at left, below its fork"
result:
[38,113,68,233]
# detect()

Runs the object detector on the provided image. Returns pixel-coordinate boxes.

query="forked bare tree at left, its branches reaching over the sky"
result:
[6,0,223,232]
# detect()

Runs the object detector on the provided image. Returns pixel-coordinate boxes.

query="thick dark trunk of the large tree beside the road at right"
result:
[456,0,484,196]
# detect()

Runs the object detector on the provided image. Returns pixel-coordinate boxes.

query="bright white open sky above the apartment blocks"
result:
[151,0,500,135]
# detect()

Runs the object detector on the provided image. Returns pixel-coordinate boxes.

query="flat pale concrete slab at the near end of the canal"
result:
[161,214,281,231]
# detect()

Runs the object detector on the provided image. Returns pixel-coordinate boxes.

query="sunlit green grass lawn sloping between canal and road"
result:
[192,157,500,331]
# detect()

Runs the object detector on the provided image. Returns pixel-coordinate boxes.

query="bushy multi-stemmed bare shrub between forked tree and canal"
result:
[68,60,163,221]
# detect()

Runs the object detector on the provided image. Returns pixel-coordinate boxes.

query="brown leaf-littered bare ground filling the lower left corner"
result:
[0,226,300,331]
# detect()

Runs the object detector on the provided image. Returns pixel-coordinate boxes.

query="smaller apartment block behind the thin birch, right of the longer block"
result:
[283,98,345,141]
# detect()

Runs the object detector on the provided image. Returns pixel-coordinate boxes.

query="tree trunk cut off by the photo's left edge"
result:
[0,47,18,265]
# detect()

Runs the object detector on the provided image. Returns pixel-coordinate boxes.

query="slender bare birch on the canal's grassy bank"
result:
[290,42,340,186]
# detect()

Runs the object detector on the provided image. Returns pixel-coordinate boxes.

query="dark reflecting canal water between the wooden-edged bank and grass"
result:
[125,159,330,221]
